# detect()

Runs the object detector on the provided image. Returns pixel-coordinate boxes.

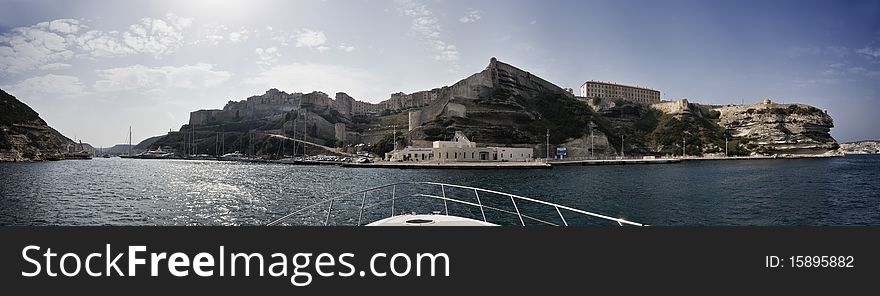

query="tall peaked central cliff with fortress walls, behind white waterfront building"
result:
[408,58,608,156]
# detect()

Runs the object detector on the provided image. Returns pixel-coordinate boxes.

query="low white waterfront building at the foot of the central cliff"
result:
[385,131,533,162]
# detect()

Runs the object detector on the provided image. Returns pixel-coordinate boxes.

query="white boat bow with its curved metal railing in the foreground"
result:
[267,182,645,226]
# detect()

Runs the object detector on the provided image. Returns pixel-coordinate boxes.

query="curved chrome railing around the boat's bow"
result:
[267,182,645,226]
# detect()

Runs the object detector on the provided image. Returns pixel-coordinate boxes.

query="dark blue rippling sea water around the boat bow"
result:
[0,155,880,225]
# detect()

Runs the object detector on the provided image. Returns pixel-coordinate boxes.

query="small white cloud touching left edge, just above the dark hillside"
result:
[0,74,85,99]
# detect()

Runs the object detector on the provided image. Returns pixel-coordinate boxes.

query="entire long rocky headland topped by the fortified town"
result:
[151,58,838,157]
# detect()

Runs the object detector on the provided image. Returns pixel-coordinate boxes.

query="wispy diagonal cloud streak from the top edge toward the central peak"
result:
[398,0,459,62]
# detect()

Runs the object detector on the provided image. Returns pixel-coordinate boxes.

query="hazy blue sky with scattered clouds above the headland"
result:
[0,0,880,147]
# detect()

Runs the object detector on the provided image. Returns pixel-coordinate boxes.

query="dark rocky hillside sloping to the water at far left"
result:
[0,90,74,161]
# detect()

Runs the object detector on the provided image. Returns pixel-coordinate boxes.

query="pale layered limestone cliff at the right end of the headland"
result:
[712,100,838,154]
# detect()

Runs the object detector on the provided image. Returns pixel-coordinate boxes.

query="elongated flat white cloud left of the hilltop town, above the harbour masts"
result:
[95,64,232,92]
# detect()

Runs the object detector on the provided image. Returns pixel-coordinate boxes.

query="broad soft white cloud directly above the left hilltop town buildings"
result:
[244,63,385,101]
